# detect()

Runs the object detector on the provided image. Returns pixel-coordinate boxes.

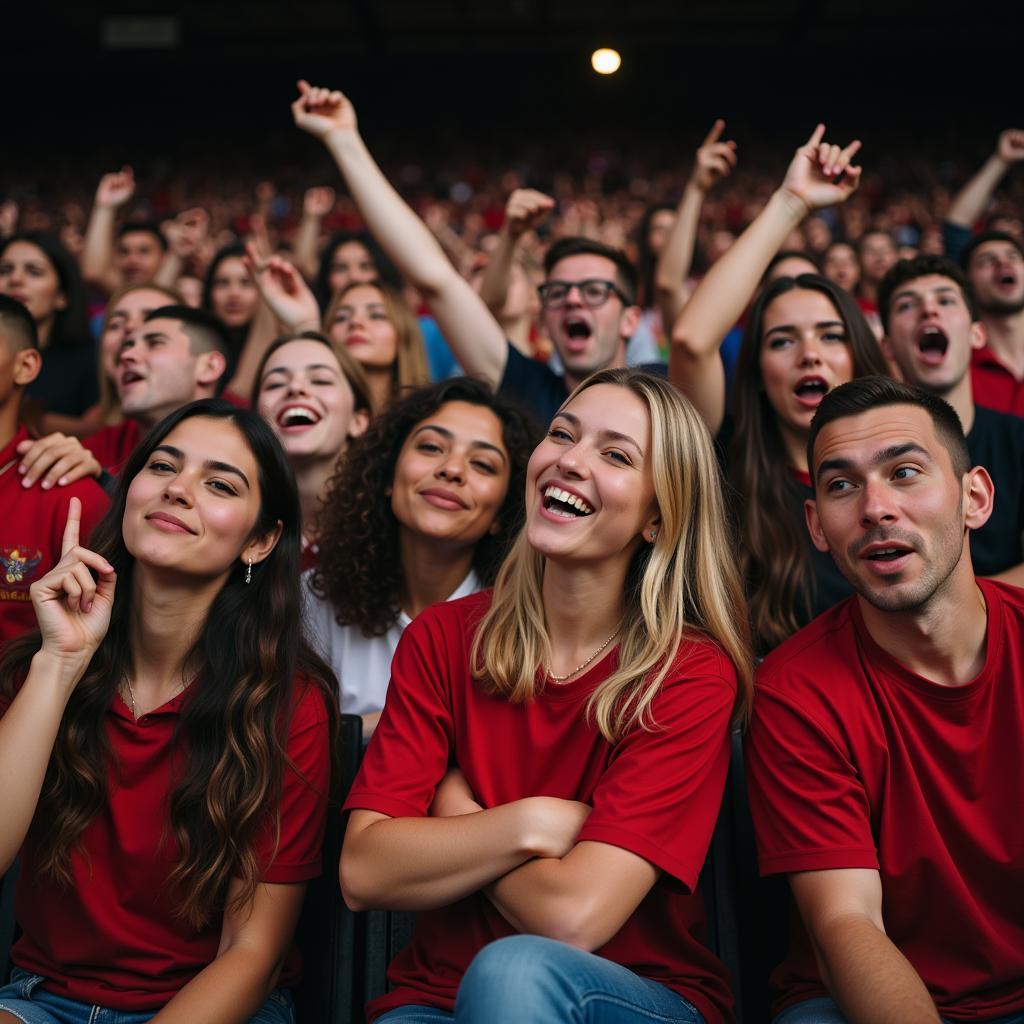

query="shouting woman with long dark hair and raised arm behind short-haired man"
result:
[669,125,887,650]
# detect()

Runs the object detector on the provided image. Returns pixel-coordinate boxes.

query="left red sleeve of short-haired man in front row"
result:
[744,684,879,874]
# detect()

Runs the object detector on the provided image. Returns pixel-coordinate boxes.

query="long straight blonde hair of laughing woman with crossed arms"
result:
[471,370,754,742]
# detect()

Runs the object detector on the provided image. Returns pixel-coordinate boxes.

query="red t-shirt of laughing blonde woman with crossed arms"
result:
[345,591,736,1022]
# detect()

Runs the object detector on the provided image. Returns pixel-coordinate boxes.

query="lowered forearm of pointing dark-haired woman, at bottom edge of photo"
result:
[153,945,282,1024]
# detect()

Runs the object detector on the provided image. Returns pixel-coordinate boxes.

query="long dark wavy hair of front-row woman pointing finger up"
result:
[0,398,340,928]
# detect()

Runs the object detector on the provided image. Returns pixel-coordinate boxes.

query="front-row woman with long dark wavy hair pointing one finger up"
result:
[0,399,337,1024]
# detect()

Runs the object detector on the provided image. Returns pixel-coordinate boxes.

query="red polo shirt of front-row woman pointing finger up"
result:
[0,681,330,1013]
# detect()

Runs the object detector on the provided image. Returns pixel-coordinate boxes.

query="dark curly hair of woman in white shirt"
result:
[312,377,538,637]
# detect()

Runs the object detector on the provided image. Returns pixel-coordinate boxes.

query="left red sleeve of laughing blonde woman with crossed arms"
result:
[345,612,458,818]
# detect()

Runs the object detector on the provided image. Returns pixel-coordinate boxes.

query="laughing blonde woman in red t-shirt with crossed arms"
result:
[340,370,753,1024]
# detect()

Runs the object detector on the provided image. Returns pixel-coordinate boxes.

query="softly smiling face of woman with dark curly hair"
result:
[391,401,509,548]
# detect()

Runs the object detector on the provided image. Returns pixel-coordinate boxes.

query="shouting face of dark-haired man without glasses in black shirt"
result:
[883,273,984,394]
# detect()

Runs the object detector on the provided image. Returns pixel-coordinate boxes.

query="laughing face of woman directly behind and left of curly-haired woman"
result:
[256,338,369,462]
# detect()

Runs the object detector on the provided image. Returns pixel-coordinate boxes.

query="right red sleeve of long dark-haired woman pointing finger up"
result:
[257,683,331,883]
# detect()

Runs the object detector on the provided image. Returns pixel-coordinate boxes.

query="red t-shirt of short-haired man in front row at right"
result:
[746,580,1024,1021]
